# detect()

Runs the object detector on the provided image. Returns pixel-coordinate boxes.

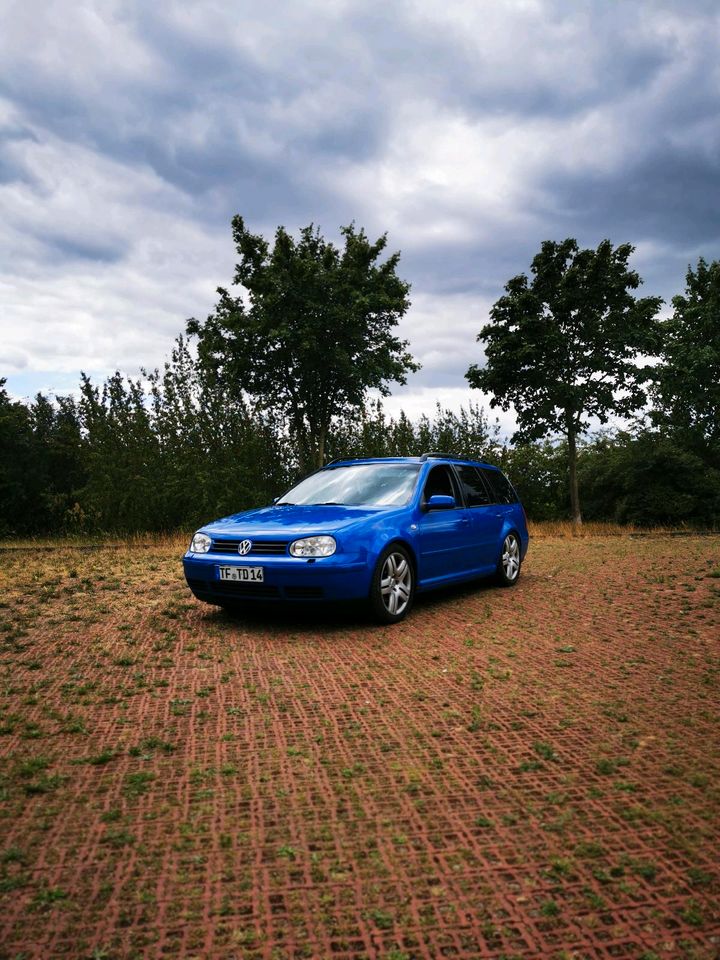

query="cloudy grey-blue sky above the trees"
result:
[0,0,720,424]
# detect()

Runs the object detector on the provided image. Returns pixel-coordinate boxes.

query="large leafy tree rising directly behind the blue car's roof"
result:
[188,216,418,469]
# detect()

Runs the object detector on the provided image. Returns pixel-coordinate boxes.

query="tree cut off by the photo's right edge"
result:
[652,258,720,458]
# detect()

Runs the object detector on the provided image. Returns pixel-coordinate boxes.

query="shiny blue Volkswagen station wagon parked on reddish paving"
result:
[183,453,529,623]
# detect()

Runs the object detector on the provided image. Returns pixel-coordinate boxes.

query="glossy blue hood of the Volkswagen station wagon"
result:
[202,505,390,537]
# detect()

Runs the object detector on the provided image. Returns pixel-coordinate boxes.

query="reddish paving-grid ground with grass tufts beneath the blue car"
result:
[0,537,720,960]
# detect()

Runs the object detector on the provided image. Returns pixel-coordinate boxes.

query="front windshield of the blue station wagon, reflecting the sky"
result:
[278,463,420,507]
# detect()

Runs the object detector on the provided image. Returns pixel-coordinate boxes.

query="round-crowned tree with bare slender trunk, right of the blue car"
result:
[465,238,662,523]
